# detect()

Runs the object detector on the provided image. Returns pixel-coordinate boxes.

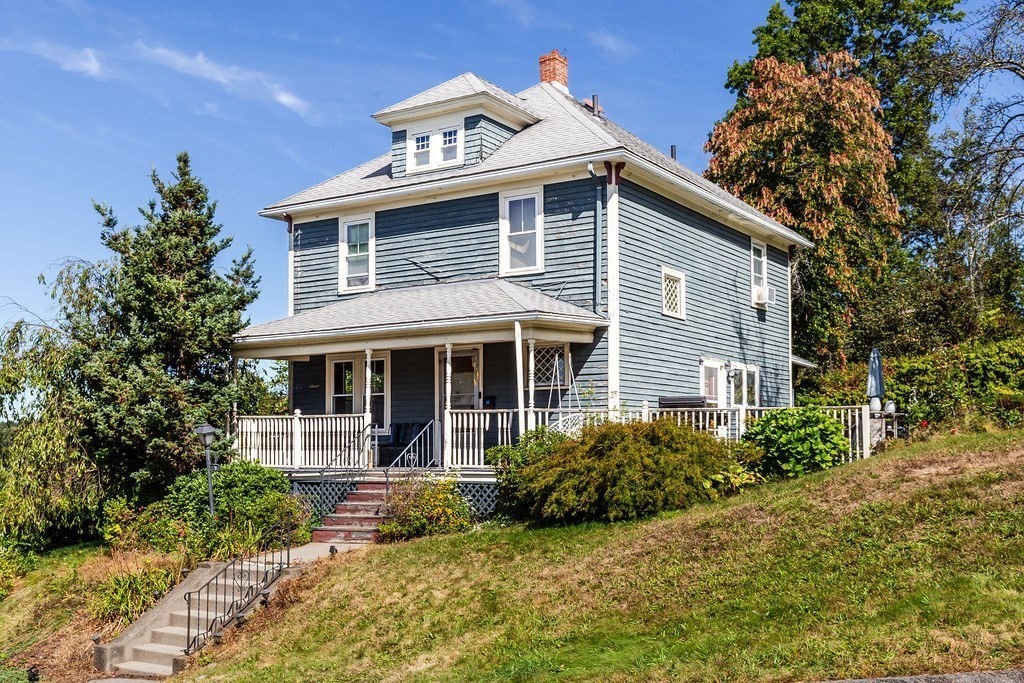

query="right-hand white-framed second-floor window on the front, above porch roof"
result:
[498,187,544,275]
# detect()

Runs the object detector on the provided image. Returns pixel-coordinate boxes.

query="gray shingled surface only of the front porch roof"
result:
[236,279,607,344]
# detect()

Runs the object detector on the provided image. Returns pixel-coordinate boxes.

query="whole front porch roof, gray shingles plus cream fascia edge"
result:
[233,279,608,357]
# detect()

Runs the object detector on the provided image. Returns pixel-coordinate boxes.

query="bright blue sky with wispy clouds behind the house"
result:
[0,0,835,323]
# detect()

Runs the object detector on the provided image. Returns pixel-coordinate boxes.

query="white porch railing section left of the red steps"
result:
[234,411,371,470]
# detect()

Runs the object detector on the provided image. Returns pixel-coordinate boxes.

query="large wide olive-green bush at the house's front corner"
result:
[519,420,735,521]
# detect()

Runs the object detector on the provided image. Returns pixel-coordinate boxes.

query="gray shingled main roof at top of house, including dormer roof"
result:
[265,74,805,248]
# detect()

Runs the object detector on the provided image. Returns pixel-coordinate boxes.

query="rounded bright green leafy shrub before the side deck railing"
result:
[743,408,850,477]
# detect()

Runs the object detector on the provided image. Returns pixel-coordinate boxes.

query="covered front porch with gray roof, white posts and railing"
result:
[233,280,607,477]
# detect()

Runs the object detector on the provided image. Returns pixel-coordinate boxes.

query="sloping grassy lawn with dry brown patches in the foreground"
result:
[182,432,1024,682]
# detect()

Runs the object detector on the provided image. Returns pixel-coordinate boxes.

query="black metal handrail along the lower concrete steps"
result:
[184,516,292,654]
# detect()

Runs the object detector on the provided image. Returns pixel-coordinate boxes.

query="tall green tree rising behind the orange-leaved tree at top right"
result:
[726,0,963,239]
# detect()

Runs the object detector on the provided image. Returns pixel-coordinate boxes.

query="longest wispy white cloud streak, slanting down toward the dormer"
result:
[133,40,310,117]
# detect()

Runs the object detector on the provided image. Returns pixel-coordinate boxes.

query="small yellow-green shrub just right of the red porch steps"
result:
[379,476,472,543]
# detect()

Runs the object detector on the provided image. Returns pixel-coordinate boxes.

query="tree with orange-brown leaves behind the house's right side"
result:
[705,52,900,366]
